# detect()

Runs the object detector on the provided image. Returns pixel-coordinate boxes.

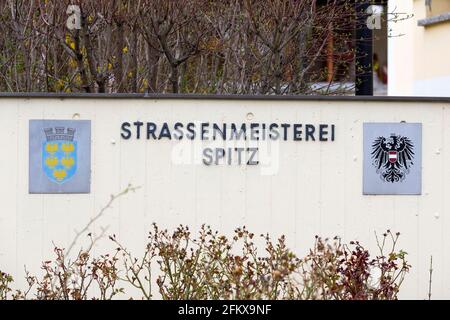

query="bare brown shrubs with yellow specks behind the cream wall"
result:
[0,0,360,94]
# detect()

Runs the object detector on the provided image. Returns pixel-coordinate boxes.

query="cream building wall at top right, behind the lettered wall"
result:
[388,0,450,96]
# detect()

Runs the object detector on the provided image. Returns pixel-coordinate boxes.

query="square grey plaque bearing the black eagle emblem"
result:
[363,122,422,195]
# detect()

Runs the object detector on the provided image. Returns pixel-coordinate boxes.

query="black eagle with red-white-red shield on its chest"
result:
[372,134,414,183]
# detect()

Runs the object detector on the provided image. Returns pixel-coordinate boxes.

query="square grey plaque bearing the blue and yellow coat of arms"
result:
[28,120,91,194]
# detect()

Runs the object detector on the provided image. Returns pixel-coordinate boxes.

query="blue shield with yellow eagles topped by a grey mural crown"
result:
[42,128,77,184]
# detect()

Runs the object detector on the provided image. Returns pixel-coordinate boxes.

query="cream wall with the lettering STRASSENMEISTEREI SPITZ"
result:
[0,98,450,299]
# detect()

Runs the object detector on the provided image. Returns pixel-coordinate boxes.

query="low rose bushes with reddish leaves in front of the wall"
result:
[0,224,410,300]
